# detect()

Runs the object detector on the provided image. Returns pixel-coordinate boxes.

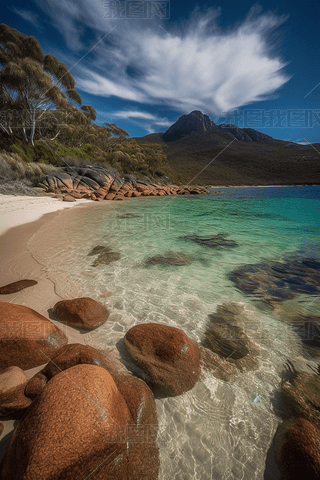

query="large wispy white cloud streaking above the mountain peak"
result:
[34,0,289,120]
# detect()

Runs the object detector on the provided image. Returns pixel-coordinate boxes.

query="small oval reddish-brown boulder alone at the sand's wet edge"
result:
[53,297,109,330]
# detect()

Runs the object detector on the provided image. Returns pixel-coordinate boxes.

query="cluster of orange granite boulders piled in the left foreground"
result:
[0,279,208,480]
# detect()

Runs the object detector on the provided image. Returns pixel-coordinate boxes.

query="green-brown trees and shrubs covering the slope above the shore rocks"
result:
[0,24,182,188]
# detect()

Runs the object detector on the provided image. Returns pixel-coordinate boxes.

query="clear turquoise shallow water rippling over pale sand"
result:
[29,187,320,480]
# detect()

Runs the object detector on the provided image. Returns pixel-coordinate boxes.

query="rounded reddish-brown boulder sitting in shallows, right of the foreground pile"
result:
[124,323,200,395]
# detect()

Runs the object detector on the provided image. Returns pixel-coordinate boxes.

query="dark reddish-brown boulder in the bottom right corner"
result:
[274,418,320,480]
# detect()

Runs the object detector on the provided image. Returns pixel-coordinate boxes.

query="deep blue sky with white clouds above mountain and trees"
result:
[0,0,320,143]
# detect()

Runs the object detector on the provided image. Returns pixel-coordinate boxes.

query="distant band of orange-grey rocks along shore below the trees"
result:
[37,165,209,202]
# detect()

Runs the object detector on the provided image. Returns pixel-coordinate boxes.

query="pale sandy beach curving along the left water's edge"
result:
[0,195,119,461]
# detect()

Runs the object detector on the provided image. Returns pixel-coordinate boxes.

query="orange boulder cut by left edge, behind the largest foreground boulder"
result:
[0,302,68,370]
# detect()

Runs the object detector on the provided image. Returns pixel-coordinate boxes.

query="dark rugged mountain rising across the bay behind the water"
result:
[135,110,320,186]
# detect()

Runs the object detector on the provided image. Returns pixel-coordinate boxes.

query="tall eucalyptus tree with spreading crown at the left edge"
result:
[0,23,89,144]
